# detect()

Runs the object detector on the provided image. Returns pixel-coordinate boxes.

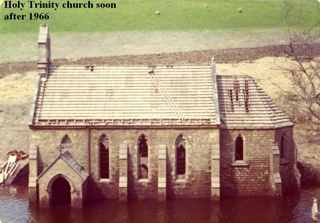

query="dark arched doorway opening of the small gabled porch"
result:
[51,177,71,206]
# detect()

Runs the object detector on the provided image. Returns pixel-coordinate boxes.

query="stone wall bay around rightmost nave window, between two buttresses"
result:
[167,131,219,198]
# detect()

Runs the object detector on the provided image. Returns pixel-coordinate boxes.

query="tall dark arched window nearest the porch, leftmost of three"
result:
[99,134,109,179]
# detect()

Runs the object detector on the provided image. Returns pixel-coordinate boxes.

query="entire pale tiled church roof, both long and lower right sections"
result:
[29,66,293,128]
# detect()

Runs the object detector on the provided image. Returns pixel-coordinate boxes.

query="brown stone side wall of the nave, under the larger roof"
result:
[30,128,220,200]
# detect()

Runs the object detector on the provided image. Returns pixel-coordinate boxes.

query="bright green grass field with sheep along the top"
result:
[0,0,320,33]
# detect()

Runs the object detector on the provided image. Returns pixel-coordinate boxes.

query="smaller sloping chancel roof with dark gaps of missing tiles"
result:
[217,75,293,128]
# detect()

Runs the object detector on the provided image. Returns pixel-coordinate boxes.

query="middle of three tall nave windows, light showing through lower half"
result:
[138,134,148,179]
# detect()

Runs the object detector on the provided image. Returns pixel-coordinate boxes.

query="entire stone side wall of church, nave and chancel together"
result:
[30,127,300,200]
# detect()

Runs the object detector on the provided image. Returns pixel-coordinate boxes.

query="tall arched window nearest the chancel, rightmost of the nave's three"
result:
[176,134,186,178]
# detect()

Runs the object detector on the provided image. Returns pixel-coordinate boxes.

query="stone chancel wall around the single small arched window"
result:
[220,129,274,196]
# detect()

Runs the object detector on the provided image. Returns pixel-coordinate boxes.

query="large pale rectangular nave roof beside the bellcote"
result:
[32,66,218,126]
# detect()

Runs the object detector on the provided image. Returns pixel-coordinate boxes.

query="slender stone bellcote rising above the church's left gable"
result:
[38,24,51,78]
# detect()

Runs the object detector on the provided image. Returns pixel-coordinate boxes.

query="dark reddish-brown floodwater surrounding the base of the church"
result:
[0,180,320,223]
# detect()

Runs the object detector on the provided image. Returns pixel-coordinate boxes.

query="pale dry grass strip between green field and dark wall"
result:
[0,26,286,63]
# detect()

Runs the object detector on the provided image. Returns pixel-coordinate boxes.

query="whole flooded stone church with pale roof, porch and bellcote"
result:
[29,25,300,207]
